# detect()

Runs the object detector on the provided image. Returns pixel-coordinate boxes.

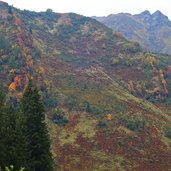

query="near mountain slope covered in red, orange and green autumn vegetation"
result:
[0,2,171,171]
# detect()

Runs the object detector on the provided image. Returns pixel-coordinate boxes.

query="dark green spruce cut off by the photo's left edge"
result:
[0,90,17,168]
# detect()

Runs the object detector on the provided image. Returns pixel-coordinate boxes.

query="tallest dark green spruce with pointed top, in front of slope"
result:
[21,80,53,171]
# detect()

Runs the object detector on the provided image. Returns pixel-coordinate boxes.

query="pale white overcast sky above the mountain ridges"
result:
[4,0,171,20]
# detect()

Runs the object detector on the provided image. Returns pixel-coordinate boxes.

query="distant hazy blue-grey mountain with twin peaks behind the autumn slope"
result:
[93,11,171,54]
